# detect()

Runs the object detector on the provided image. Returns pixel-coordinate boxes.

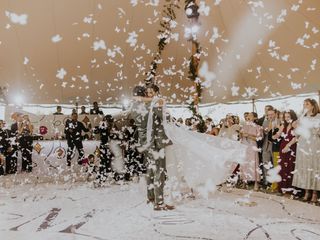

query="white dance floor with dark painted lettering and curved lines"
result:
[0,178,320,240]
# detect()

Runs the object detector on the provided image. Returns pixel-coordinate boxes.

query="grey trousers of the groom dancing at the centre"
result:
[145,150,166,205]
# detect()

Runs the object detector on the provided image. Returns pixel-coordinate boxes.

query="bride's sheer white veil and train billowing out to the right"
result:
[147,98,247,198]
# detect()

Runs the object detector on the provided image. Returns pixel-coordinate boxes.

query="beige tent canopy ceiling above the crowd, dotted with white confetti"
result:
[0,0,320,104]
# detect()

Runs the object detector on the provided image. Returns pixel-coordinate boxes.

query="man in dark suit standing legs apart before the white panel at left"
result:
[64,113,89,166]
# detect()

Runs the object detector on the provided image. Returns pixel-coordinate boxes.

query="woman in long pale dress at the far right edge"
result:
[288,98,320,203]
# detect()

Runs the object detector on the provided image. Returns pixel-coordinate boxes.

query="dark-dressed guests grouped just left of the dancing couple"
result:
[65,110,145,184]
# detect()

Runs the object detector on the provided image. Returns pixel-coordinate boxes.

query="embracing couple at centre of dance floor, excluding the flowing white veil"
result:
[128,86,173,210]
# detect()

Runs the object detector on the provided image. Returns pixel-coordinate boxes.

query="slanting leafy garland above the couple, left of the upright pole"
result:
[145,0,180,85]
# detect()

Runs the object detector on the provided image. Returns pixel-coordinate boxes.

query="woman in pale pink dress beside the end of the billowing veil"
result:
[240,113,261,190]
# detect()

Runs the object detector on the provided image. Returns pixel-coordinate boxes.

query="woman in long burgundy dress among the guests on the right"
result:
[273,110,297,194]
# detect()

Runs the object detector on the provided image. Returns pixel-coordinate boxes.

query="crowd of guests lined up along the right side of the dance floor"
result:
[177,98,320,204]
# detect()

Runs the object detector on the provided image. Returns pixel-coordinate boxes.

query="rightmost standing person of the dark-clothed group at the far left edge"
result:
[18,115,33,172]
